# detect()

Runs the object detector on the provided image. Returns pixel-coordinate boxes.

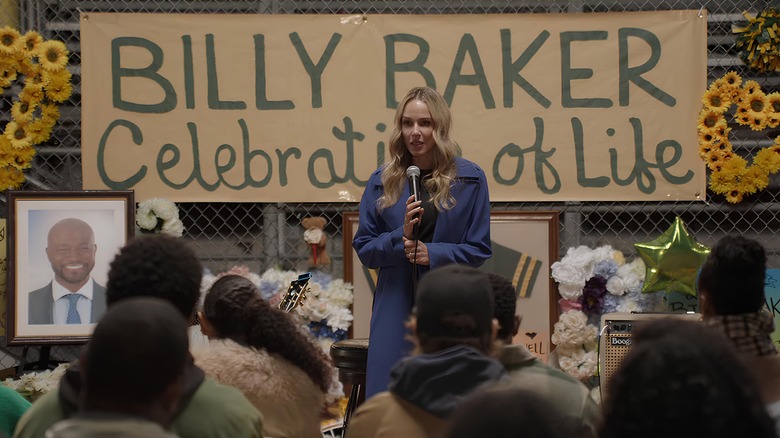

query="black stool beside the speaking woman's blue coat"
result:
[330,338,368,436]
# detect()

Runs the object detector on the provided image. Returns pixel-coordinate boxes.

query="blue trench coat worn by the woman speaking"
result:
[352,158,491,398]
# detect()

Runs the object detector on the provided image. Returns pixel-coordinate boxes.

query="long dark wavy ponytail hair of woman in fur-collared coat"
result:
[203,275,332,392]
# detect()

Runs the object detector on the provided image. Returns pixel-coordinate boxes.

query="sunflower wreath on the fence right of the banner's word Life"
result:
[698,71,780,204]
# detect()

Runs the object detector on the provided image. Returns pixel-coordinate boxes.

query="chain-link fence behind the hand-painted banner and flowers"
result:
[0,0,780,369]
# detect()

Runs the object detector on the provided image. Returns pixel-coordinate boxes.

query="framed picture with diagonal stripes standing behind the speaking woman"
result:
[342,211,559,362]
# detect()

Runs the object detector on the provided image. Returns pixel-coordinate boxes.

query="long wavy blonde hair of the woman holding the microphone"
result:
[377,87,460,211]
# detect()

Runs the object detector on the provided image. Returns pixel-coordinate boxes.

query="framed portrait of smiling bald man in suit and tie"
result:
[6,191,135,345]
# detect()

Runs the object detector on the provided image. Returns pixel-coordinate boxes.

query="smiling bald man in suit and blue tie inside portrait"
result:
[28,218,106,324]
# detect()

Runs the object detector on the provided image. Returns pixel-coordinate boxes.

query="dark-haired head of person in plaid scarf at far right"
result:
[698,236,766,318]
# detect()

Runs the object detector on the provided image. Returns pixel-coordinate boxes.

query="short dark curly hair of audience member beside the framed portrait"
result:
[106,234,203,318]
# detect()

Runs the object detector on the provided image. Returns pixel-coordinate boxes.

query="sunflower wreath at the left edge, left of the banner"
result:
[0,26,73,190]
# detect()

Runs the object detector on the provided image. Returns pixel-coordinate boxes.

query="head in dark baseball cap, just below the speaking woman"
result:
[411,265,498,354]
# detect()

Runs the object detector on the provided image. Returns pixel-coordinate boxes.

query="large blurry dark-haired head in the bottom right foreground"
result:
[599,319,775,438]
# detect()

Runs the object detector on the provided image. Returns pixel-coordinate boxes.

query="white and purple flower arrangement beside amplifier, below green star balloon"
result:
[551,245,663,380]
